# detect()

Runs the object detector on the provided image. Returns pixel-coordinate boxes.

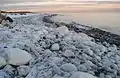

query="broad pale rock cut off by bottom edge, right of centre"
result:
[70,72,97,78]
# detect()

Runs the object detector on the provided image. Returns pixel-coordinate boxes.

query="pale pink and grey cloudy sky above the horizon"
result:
[0,0,120,12]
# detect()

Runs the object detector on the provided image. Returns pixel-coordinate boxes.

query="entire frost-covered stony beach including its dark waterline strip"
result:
[0,14,120,78]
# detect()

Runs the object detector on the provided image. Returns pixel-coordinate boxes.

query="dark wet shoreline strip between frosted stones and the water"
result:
[43,14,120,46]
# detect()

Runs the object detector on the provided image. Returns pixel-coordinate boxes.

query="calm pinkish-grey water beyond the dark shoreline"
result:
[57,12,120,35]
